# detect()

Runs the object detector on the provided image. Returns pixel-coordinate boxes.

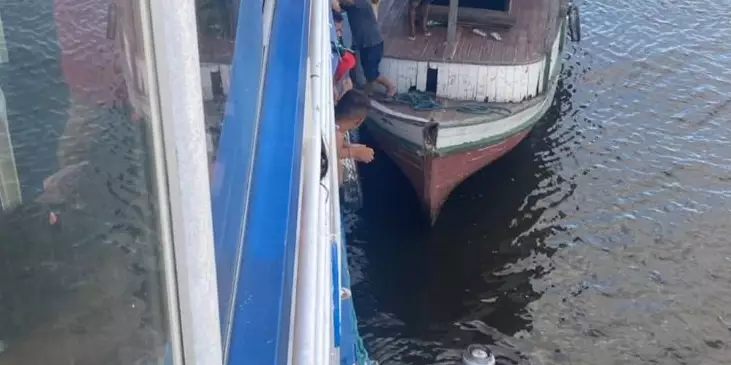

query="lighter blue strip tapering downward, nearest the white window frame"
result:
[211,0,263,343]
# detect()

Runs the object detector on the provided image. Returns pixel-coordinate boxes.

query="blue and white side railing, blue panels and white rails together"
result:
[213,0,340,364]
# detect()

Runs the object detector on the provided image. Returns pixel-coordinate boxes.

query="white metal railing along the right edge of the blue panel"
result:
[291,0,345,358]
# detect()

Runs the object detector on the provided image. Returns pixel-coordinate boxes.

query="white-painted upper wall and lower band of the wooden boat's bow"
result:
[370,26,563,150]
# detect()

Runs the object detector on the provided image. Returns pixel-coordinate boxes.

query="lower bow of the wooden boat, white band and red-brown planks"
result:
[366,72,558,224]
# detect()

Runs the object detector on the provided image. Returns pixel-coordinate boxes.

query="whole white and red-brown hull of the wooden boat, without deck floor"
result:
[366,5,566,224]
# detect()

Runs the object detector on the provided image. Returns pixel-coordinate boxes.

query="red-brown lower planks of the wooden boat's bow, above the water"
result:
[369,124,530,224]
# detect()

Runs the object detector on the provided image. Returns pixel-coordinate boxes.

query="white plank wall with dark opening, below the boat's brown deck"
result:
[381,24,564,103]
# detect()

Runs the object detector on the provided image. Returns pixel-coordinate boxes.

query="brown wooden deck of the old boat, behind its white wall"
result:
[378,0,565,65]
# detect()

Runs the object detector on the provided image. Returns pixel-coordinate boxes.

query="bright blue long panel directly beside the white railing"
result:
[227,0,310,365]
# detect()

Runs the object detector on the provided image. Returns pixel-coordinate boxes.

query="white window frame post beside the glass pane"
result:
[140,0,223,365]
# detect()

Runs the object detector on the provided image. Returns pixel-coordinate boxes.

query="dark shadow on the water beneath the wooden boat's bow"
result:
[349,78,570,364]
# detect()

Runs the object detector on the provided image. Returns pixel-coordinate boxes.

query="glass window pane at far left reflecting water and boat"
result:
[0,0,168,365]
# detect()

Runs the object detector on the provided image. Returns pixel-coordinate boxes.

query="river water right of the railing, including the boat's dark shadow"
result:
[349,0,731,365]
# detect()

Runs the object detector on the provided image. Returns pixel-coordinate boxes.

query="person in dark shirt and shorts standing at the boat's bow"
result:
[333,0,396,97]
